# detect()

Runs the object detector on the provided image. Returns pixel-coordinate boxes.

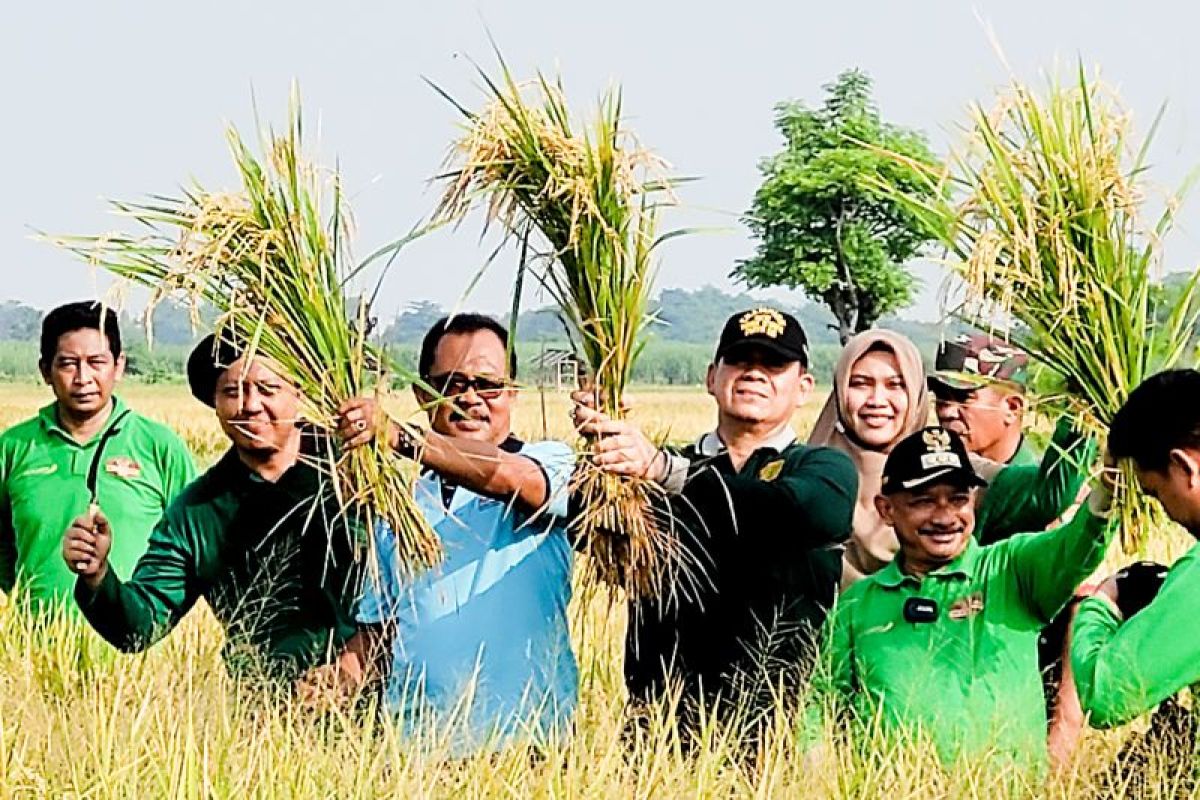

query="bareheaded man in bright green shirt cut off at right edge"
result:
[1070,369,1200,728]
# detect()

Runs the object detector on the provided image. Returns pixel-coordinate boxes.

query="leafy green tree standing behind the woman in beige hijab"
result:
[732,70,934,343]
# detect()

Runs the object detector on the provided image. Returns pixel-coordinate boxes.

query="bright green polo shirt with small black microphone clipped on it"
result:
[808,507,1110,766]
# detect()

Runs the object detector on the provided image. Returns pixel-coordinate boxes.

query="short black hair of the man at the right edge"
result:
[1109,369,1200,470]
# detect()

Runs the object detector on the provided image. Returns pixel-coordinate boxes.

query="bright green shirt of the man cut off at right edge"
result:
[1070,545,1200,728]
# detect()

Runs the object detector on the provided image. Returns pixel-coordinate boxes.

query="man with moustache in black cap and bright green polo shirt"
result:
[808,427,1109,766]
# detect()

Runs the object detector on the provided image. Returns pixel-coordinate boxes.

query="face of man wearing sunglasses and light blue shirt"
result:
[416,330,516,445]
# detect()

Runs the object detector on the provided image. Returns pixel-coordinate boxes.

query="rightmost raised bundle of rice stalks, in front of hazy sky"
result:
[881,67,1196,548]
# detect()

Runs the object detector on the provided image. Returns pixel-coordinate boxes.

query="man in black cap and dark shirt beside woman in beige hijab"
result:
[576,307,858,724]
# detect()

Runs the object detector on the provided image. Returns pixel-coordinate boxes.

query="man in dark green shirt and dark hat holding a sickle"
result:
[62,336,361,680]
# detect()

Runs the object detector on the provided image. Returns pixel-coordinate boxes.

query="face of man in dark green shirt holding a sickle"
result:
[216,359,300,453]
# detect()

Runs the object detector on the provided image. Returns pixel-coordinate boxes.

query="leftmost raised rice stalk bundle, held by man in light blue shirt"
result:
[54,96,440,569]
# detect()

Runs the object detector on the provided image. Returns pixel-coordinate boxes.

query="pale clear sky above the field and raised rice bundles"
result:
[0,0,1200,319]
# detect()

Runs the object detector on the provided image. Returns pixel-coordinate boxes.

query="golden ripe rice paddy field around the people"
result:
[0,384,1190,800]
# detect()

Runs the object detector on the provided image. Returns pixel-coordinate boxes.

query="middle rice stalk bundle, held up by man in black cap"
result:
[434,60,683,599]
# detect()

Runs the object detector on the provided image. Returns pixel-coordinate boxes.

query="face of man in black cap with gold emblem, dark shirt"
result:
[707,345,812,426]
